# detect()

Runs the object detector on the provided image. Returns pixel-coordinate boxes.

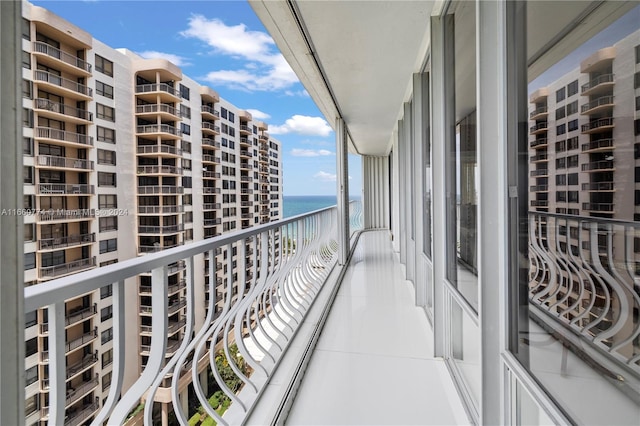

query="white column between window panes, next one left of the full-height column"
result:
[431,15,454,357]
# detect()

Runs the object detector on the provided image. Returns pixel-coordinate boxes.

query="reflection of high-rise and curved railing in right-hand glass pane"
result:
[525,26,640,423]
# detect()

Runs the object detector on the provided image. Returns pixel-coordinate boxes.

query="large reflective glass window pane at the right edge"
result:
[511,1,640,424]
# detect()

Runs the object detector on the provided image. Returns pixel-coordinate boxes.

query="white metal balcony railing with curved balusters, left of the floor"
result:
[24,207,358,424]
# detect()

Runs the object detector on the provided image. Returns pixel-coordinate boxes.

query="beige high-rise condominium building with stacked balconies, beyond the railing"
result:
[22,3,282,425]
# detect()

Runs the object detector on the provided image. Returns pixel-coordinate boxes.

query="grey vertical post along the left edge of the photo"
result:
[0,1,24,425]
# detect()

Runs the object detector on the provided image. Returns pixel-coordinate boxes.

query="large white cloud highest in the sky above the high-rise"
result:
[180,15,298,91]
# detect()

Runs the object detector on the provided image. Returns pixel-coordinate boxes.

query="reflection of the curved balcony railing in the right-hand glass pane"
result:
[529,212,640,401]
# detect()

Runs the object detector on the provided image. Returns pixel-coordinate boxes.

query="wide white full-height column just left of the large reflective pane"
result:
[476,1,508,424]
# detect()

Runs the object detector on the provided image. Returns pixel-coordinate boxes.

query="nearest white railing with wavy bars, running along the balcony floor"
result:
[24,207,360,425]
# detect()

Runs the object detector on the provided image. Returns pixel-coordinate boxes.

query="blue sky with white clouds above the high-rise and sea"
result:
[32,0,361,195]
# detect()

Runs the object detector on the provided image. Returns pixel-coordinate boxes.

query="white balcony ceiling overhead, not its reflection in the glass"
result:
[250,0,437,155]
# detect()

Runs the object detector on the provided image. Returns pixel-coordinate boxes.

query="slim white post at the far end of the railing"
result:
[336,118,350,265]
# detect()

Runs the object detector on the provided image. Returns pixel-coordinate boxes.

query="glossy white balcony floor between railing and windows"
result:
[287,231,469,425]
